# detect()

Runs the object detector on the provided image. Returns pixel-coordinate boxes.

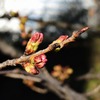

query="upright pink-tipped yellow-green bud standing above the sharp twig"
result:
[25,32,43,55]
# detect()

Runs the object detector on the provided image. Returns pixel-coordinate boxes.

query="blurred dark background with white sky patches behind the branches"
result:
[0,0,100,100]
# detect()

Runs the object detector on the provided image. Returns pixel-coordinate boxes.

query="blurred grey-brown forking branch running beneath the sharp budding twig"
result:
[0,68,87,100]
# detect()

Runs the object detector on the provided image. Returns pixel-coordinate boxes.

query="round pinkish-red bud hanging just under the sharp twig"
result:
[34,54,47,68]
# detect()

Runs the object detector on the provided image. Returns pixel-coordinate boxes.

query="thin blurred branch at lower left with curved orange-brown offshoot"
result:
[0,69,48,94]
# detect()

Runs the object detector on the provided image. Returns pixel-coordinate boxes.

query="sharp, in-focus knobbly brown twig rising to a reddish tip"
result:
[0,27,89,69]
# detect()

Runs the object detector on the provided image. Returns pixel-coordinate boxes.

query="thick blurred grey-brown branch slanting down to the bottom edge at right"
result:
[40,68,87,100]
